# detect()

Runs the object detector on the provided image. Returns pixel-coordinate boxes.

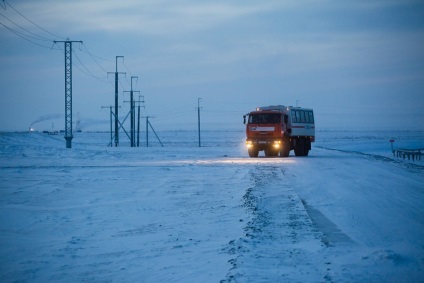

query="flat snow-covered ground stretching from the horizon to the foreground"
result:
[0,131,424,282]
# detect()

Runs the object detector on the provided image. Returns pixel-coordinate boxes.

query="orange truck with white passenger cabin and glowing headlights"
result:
[243,105,315,157]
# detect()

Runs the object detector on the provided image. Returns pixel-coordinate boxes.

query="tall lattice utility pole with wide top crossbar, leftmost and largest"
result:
[53,40,82,151]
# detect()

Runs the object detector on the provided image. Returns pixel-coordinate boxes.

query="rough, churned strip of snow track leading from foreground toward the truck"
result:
[221,166,331,282]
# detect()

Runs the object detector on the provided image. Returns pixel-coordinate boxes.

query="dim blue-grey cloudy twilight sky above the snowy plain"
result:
[0,0,424,131]
